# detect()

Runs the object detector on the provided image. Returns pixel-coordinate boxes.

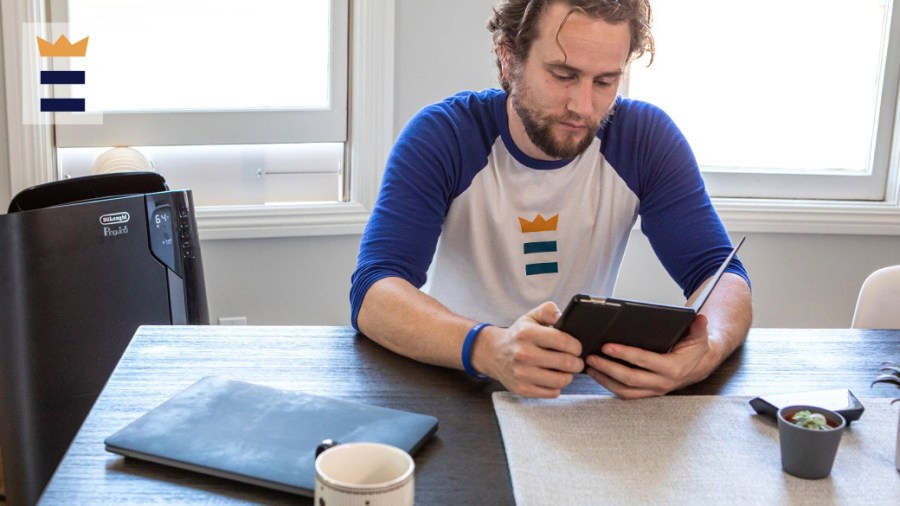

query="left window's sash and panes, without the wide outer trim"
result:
[51,0,348,206]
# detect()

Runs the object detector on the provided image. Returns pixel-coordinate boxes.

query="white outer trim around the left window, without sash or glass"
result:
[0,0,395,239]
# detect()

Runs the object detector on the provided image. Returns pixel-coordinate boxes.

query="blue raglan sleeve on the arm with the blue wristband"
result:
[350,94,497,330]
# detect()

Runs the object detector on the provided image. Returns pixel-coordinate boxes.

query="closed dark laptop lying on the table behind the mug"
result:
[104,376,438,497]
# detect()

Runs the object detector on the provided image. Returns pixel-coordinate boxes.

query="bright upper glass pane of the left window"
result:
[68,0,331,113]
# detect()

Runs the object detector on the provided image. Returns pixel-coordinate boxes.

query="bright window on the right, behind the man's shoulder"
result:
[628,0,900,202]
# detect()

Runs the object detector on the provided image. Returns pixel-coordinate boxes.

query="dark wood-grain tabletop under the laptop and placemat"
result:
[41,326,900,505]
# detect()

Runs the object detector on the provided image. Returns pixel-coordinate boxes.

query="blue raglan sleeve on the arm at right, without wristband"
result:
[604,99,750,297]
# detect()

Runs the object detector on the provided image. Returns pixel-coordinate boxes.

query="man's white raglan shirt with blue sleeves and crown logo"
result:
[350,89,749,328]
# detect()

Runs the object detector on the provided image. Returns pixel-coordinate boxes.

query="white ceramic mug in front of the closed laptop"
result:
[315,443,416,506]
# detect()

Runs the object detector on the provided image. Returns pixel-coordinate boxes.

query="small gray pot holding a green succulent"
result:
[778,405,847,480]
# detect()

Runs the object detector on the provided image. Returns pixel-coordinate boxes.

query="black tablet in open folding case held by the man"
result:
[555,238,744,358]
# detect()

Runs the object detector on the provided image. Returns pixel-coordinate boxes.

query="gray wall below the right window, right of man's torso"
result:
[616,232,900,328]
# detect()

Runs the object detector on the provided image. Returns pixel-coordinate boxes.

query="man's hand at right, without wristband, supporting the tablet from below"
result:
[586,314,721,399]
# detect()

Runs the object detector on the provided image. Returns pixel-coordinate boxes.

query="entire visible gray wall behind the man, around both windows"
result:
[0,0,900,328]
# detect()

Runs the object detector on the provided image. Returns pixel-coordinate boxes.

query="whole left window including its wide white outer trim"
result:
[0,0,394,239]
